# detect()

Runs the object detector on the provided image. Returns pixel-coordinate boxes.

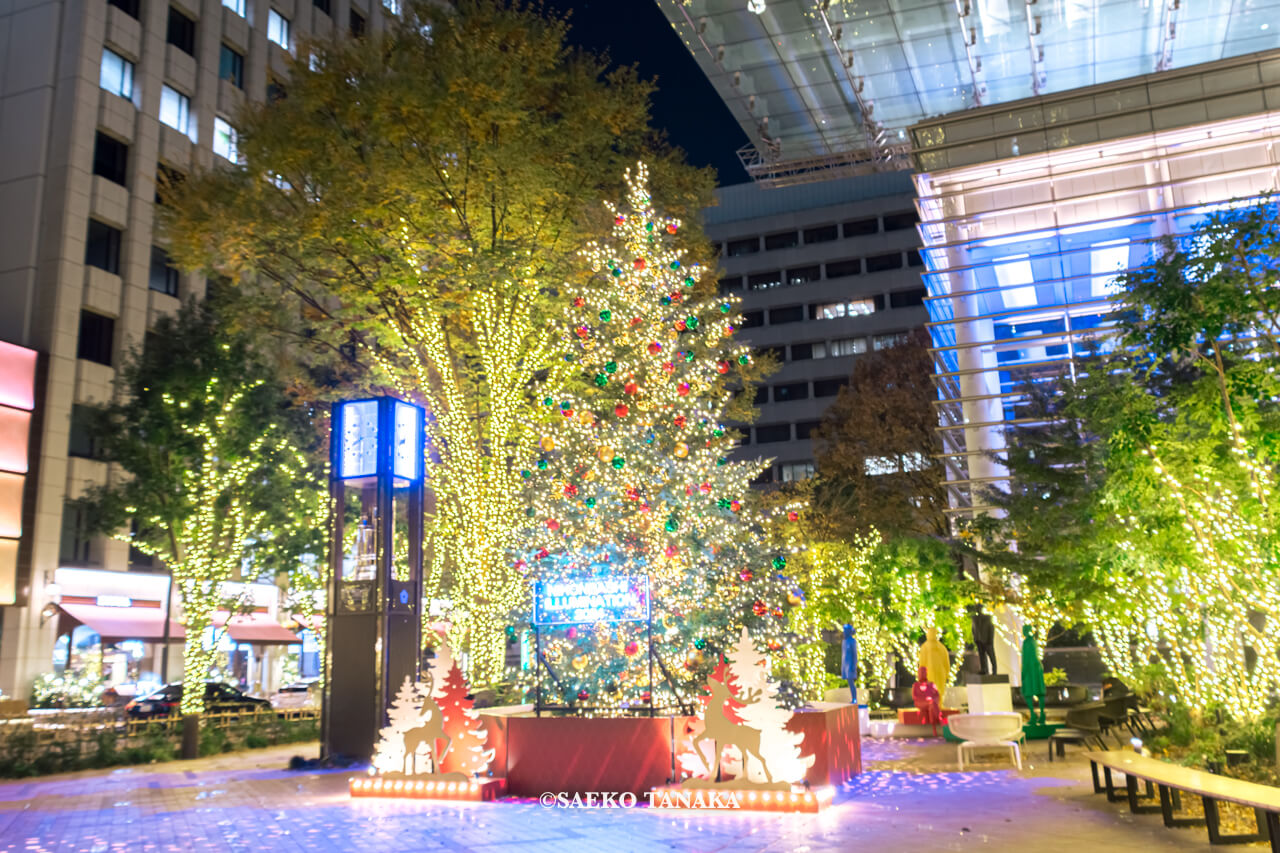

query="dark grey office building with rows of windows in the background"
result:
[704,172,927,483]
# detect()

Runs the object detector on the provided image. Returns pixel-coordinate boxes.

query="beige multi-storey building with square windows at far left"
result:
[0,0,388,698]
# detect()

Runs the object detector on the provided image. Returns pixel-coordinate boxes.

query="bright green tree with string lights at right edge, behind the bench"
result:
[987,200,1280,719]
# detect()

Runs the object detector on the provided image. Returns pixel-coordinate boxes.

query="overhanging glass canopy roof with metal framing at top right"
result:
[657,0,1280,167]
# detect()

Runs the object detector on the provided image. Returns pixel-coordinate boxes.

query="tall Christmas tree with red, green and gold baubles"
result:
[517,165,796,713]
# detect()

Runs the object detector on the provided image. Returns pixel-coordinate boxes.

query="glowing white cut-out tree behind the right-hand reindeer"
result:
[728,630,814,783]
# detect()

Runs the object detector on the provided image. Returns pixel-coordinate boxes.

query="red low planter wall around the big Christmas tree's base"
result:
[481,703,863,797]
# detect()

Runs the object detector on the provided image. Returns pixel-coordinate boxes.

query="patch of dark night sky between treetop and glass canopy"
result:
[545,0,748,186]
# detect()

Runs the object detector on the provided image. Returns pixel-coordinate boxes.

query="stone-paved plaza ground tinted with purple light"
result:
[0,739,1256,853]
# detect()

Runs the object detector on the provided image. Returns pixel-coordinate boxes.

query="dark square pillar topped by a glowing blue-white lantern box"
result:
[321,397,426,760]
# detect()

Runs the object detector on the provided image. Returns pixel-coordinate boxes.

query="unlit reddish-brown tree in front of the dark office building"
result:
[810,330,950,538]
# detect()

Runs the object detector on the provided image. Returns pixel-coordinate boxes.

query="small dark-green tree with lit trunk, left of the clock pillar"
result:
[82,301,321,713]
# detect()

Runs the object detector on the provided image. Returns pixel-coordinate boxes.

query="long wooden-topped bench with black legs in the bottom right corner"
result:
[1084,749,1280,853]
